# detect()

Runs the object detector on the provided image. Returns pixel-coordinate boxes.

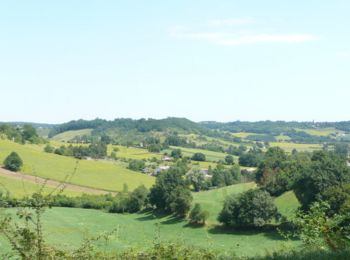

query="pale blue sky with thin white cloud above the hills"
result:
[0,0,350,123]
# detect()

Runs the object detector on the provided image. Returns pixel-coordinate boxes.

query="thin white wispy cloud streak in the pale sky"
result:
[169,18,318,46]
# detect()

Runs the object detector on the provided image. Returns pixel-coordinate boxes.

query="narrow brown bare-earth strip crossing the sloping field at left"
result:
[0,168,115,194]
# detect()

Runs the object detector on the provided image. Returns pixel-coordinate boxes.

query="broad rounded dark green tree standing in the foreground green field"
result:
[218,189,278,228]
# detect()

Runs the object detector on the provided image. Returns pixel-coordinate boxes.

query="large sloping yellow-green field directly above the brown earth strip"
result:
[0,140,154,191]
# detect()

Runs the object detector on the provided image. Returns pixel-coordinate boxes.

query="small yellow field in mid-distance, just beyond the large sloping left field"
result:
[108,145,162,160]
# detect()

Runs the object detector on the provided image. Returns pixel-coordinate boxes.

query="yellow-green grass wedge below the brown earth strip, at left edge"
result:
[0,176,82,198]
